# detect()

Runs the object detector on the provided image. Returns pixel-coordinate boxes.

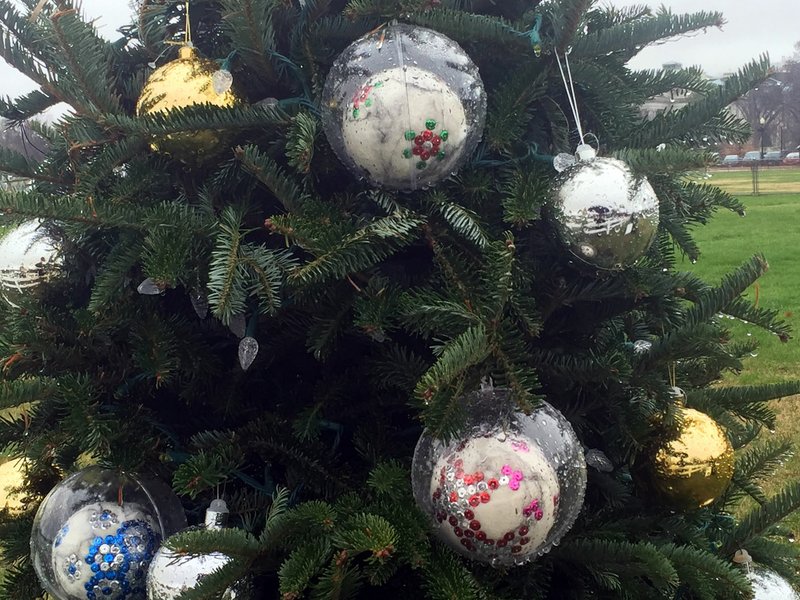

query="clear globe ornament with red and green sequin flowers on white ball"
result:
[322,25,486,190]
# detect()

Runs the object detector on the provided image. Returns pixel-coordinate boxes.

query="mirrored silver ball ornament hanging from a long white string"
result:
[549,157,659,270]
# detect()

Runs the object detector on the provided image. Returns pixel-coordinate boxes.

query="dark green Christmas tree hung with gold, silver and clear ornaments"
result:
[0,0,800,600]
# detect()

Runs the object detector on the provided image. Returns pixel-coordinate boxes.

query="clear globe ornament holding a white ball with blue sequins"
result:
[31,467,186,600]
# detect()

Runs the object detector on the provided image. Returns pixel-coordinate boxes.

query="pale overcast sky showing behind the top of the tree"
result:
[0,0,800,101]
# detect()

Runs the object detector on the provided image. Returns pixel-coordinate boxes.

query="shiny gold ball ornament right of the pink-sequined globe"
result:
[651,408,734,508]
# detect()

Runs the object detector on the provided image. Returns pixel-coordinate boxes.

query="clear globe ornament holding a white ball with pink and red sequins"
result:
[412,388,586,567]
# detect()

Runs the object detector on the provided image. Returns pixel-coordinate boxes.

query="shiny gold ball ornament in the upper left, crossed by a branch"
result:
[136,46,240,163]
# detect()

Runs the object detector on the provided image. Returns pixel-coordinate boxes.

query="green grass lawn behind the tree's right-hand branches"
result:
[686,168,800,535]
